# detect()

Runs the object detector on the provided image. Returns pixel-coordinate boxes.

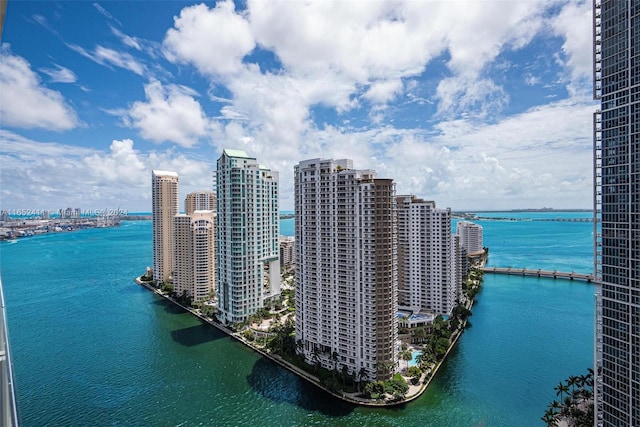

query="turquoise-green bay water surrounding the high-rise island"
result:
[0,216,595,427]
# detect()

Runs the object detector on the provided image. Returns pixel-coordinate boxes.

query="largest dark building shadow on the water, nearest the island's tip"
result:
[247,357,355,417]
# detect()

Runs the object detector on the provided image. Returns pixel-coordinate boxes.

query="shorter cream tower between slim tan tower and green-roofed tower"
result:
[173,210,215,302]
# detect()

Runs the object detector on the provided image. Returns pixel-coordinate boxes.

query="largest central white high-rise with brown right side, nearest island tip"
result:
[294,159,398,381]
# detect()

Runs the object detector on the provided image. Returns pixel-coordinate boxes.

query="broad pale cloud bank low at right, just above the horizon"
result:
[385,101,593,209]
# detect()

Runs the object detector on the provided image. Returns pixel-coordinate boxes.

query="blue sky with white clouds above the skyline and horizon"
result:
[0,0,597,212]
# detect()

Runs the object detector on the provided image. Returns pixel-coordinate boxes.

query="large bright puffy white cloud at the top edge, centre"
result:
[248,1,445,84]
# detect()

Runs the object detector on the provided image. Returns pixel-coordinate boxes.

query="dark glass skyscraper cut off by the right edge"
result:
[594,0,640,426]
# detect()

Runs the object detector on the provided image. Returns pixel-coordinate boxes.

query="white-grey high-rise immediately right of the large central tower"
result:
[396,195,462,316]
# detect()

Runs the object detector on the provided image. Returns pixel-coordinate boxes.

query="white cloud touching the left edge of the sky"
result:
[0,44,79,131]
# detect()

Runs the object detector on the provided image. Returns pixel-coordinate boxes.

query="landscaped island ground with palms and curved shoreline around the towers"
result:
[135,252,488,407]
